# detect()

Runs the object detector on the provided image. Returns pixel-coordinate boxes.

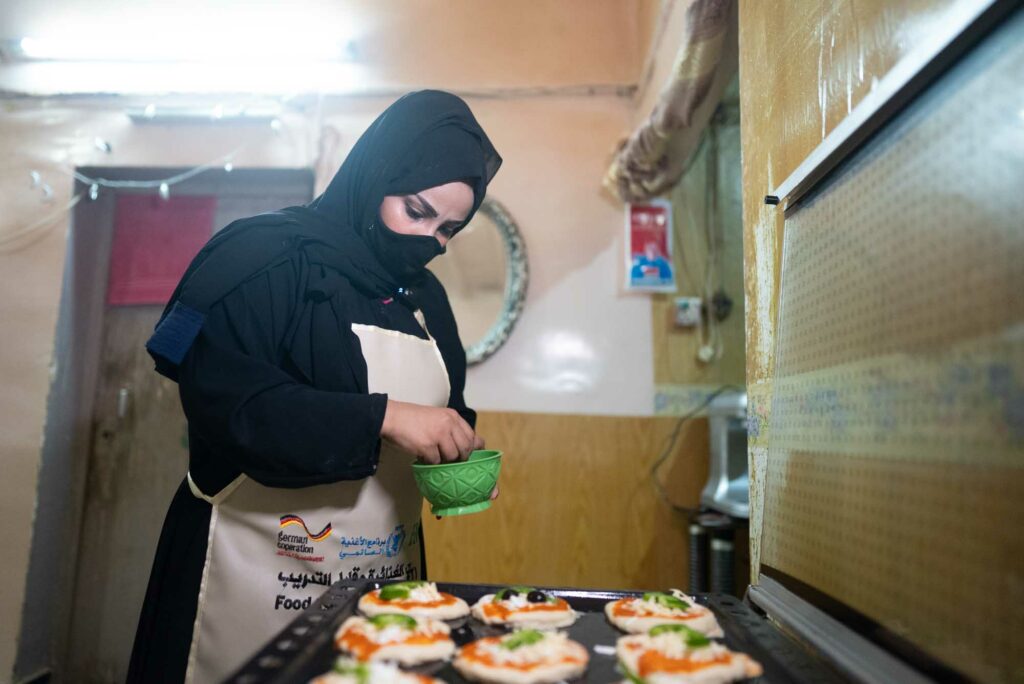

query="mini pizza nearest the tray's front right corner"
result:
[615,623,763,684]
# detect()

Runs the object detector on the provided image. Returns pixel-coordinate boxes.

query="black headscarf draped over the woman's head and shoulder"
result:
[146,90,502,379]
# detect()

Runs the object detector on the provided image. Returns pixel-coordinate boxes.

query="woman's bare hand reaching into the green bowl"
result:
[381,399,477,464]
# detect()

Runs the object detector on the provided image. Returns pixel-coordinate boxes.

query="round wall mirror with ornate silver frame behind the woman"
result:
[429,198,529,365]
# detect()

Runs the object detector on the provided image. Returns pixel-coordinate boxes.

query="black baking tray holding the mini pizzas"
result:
[224,580,846,684]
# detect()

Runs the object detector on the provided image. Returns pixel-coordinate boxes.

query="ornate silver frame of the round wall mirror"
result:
[466,198,529,366]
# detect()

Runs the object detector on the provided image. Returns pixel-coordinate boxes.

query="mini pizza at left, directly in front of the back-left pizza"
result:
[334,613,455,666]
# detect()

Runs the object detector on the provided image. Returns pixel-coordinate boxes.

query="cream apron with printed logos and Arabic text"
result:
[185,311,451,684]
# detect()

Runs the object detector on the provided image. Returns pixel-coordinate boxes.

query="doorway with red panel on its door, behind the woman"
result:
[16,167,313,683]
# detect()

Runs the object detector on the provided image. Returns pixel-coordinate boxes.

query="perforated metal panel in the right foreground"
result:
[762,12,1024,681]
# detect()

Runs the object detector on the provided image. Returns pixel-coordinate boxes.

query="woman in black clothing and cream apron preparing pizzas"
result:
[128,91,501,682]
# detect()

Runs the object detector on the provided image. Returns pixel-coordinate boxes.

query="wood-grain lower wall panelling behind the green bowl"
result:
[424,413,708,589]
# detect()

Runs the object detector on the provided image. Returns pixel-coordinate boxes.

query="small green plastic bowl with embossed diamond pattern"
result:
[413,451,502,515]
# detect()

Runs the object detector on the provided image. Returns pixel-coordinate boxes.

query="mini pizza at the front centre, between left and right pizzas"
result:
[452,630,590,684]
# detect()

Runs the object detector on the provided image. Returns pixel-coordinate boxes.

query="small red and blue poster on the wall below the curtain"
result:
[626,200,676,292]
